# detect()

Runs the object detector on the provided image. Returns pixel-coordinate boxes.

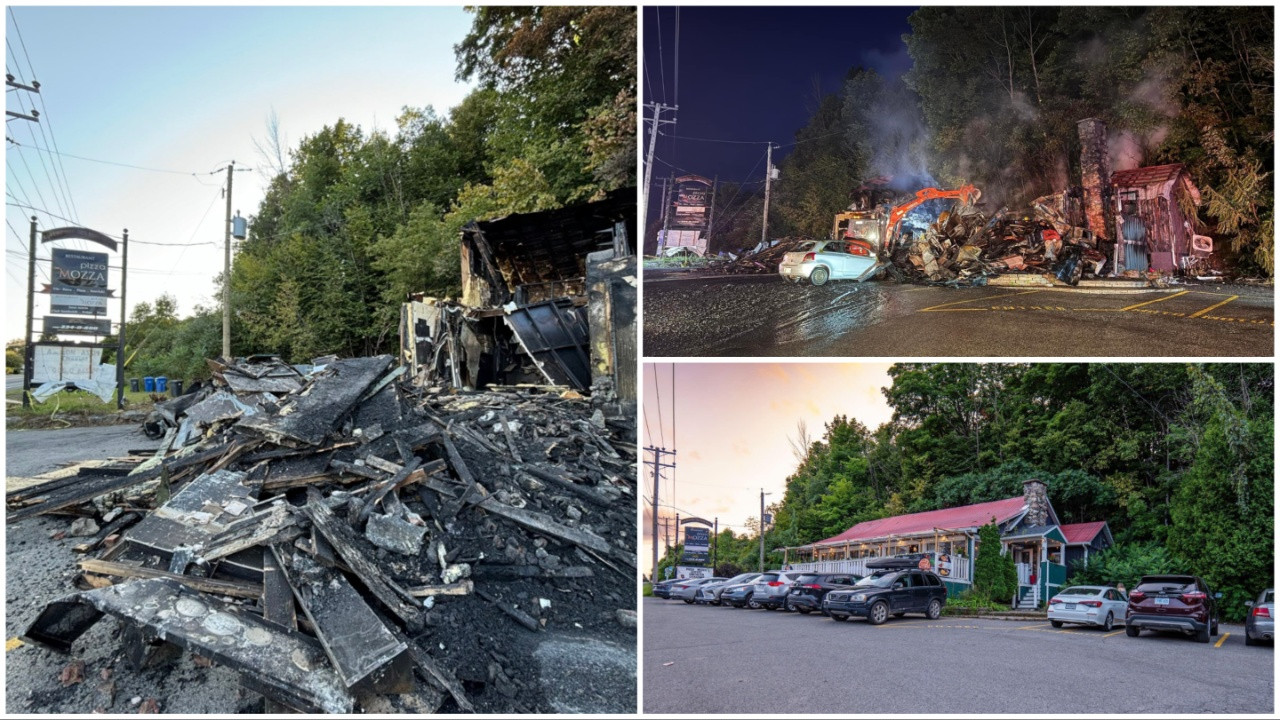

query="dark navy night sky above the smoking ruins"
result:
[641,6,915,220]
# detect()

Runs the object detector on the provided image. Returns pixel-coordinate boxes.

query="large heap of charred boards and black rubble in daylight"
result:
[6,355,636,712]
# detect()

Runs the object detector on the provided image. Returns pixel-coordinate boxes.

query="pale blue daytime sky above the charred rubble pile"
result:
[5,6,471,340]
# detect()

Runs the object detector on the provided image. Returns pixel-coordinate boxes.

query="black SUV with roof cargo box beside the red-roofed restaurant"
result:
[822,557,947,625]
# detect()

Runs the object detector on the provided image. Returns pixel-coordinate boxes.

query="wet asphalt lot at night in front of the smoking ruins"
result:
[643,275,1275,357]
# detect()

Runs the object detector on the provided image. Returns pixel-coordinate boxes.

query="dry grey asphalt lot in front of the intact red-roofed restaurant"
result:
[643,598,1275,716]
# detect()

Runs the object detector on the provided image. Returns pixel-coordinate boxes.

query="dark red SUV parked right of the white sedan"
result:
[1125,575,1222,643]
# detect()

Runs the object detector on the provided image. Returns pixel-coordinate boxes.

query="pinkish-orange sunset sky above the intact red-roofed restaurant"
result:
[639,363,893,573]
